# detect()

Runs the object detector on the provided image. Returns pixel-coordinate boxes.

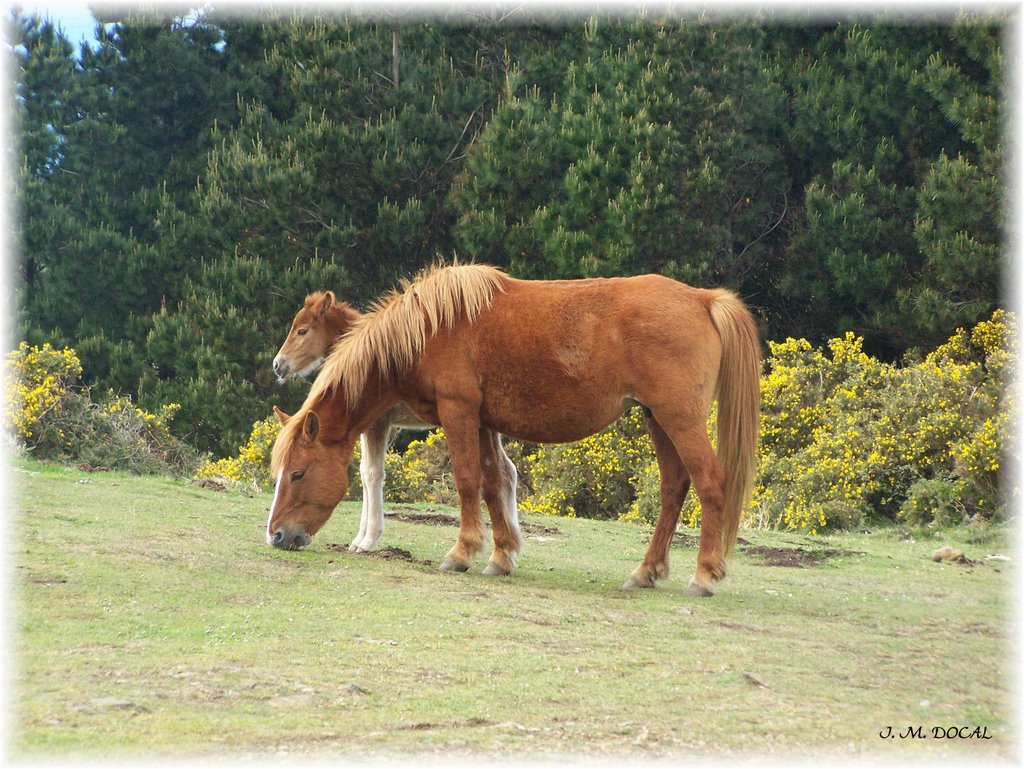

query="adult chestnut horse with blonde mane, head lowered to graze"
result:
[267,265,760,595]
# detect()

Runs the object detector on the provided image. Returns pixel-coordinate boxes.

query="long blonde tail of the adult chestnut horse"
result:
[710,289,761,558]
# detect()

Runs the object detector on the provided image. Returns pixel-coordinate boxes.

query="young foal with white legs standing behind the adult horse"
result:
[273,291,519,553]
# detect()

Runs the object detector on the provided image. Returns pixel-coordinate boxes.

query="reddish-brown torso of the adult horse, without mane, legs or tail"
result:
[403,275,721,441]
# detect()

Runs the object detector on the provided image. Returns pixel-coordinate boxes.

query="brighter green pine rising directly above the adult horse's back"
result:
[453,22,788,288]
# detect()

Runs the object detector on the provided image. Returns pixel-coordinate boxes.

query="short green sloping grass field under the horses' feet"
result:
[7,460,1019,761]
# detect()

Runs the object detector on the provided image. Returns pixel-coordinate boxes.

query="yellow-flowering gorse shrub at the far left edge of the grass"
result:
[6,342,198,474]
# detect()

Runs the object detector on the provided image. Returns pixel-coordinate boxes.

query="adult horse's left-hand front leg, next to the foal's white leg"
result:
[437,403,483,571]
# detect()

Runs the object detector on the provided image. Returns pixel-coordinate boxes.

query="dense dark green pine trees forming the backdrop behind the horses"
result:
[9,8,1006,453]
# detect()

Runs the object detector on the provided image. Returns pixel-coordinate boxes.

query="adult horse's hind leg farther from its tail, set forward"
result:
[623,412,690,588]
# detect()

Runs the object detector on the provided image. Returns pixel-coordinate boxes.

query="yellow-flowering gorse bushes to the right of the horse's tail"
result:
[755,310,1017,530]
